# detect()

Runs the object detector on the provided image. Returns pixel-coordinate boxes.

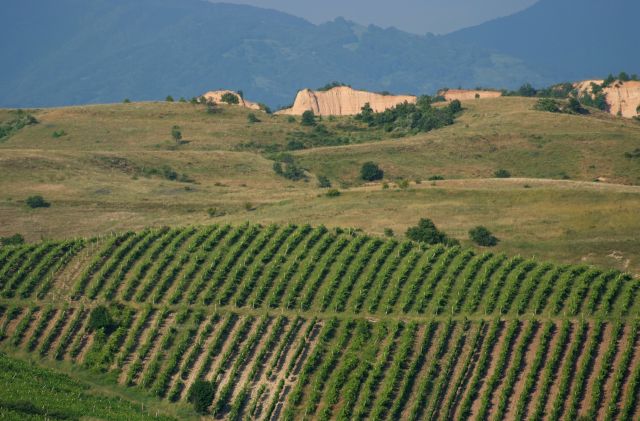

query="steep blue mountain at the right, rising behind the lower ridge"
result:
[446,0,640,81]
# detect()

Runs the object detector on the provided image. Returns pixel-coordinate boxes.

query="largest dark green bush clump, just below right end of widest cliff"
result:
[355,95,462,134]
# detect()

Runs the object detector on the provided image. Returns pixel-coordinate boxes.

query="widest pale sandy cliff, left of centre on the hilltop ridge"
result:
[276,86,417,116]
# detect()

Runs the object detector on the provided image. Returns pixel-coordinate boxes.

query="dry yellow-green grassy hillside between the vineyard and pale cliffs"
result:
[0,98,640,272]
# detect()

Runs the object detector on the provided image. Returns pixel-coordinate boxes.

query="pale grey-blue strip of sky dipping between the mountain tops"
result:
[218,0,537,34]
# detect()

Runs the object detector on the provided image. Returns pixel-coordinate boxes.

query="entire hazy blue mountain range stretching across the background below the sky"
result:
[0,0,640,107]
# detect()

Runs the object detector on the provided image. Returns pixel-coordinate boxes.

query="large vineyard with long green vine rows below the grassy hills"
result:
[0,224,640,421]
